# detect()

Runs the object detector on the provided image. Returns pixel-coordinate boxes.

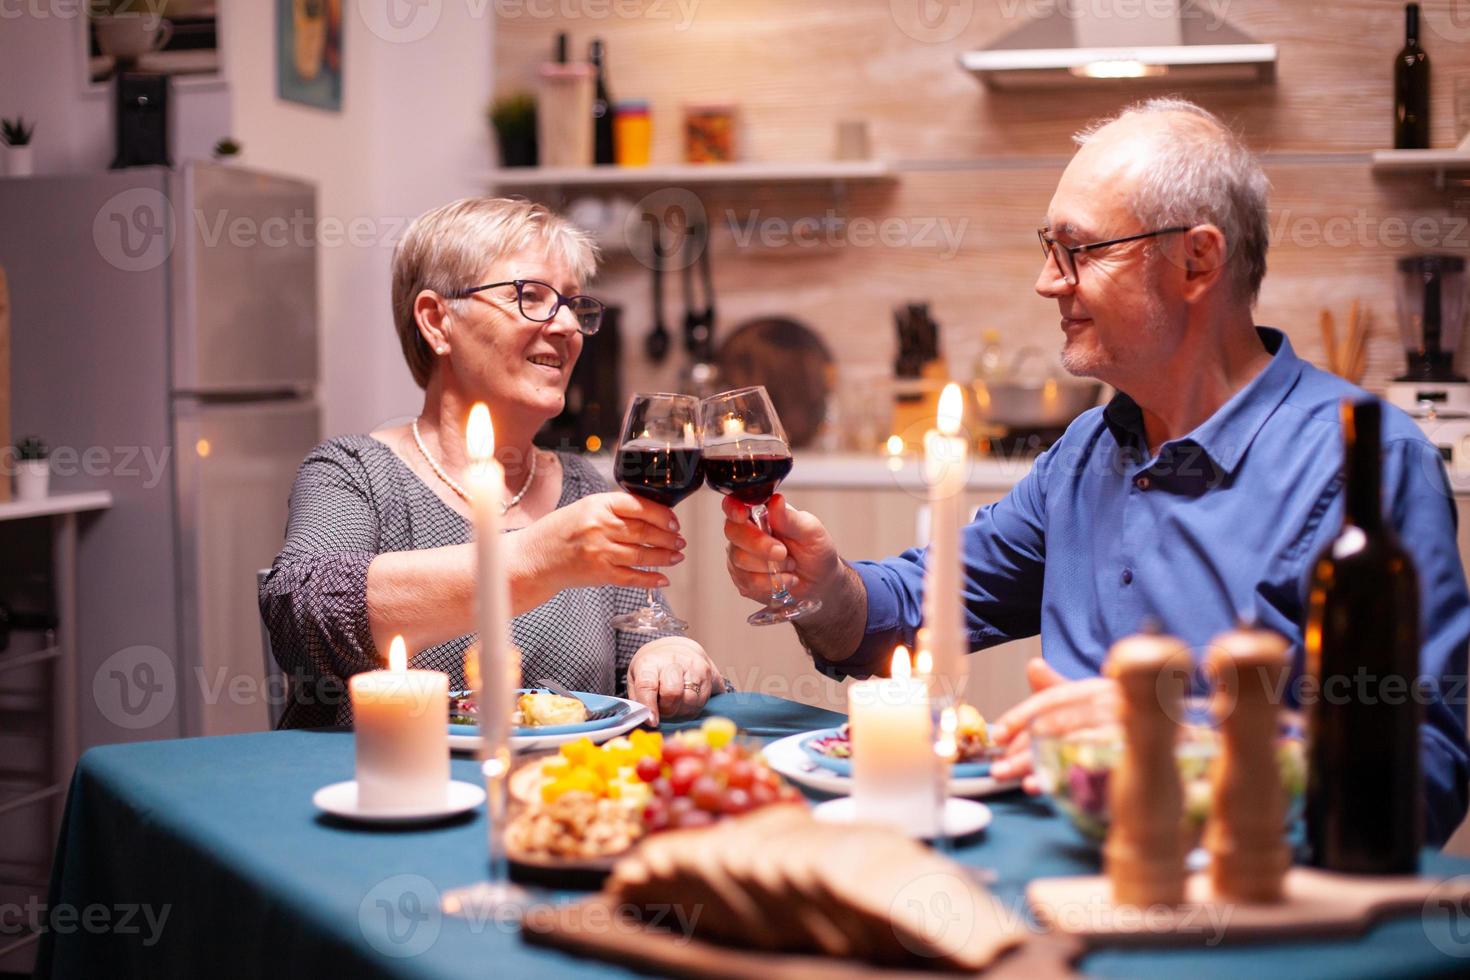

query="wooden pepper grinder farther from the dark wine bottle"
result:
[1103,626,1191,907]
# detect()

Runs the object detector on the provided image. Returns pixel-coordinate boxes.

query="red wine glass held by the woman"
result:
[613,392,704,633]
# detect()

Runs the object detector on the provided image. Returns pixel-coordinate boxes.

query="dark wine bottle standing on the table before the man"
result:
[1305,400,1423,874]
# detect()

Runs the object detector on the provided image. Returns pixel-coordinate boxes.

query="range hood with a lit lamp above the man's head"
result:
[960,0,1276,88]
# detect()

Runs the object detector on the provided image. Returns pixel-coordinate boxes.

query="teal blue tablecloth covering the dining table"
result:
[38,693,1470,980]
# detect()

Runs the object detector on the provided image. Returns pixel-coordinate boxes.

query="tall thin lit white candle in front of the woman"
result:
[465,403,523,777]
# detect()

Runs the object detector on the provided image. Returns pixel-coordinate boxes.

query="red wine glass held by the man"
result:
[700,385,822,626]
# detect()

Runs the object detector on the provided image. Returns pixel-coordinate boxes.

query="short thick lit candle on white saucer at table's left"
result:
[348,636,450,811]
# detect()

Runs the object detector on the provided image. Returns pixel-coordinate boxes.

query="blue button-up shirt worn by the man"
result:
[840,329,1470,842]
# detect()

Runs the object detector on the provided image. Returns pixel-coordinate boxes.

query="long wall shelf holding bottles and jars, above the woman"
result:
[485,160,897,187]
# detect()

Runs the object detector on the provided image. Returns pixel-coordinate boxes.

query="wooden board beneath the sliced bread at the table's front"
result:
[520,893,1083,980]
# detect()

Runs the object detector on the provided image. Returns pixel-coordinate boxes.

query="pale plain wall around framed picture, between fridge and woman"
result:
[222,0,494,435]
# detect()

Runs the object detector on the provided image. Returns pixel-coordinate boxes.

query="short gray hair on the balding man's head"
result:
[1073,98,1270,303]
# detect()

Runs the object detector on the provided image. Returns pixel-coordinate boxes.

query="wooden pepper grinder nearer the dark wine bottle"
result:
[1204,626,1291,902]
